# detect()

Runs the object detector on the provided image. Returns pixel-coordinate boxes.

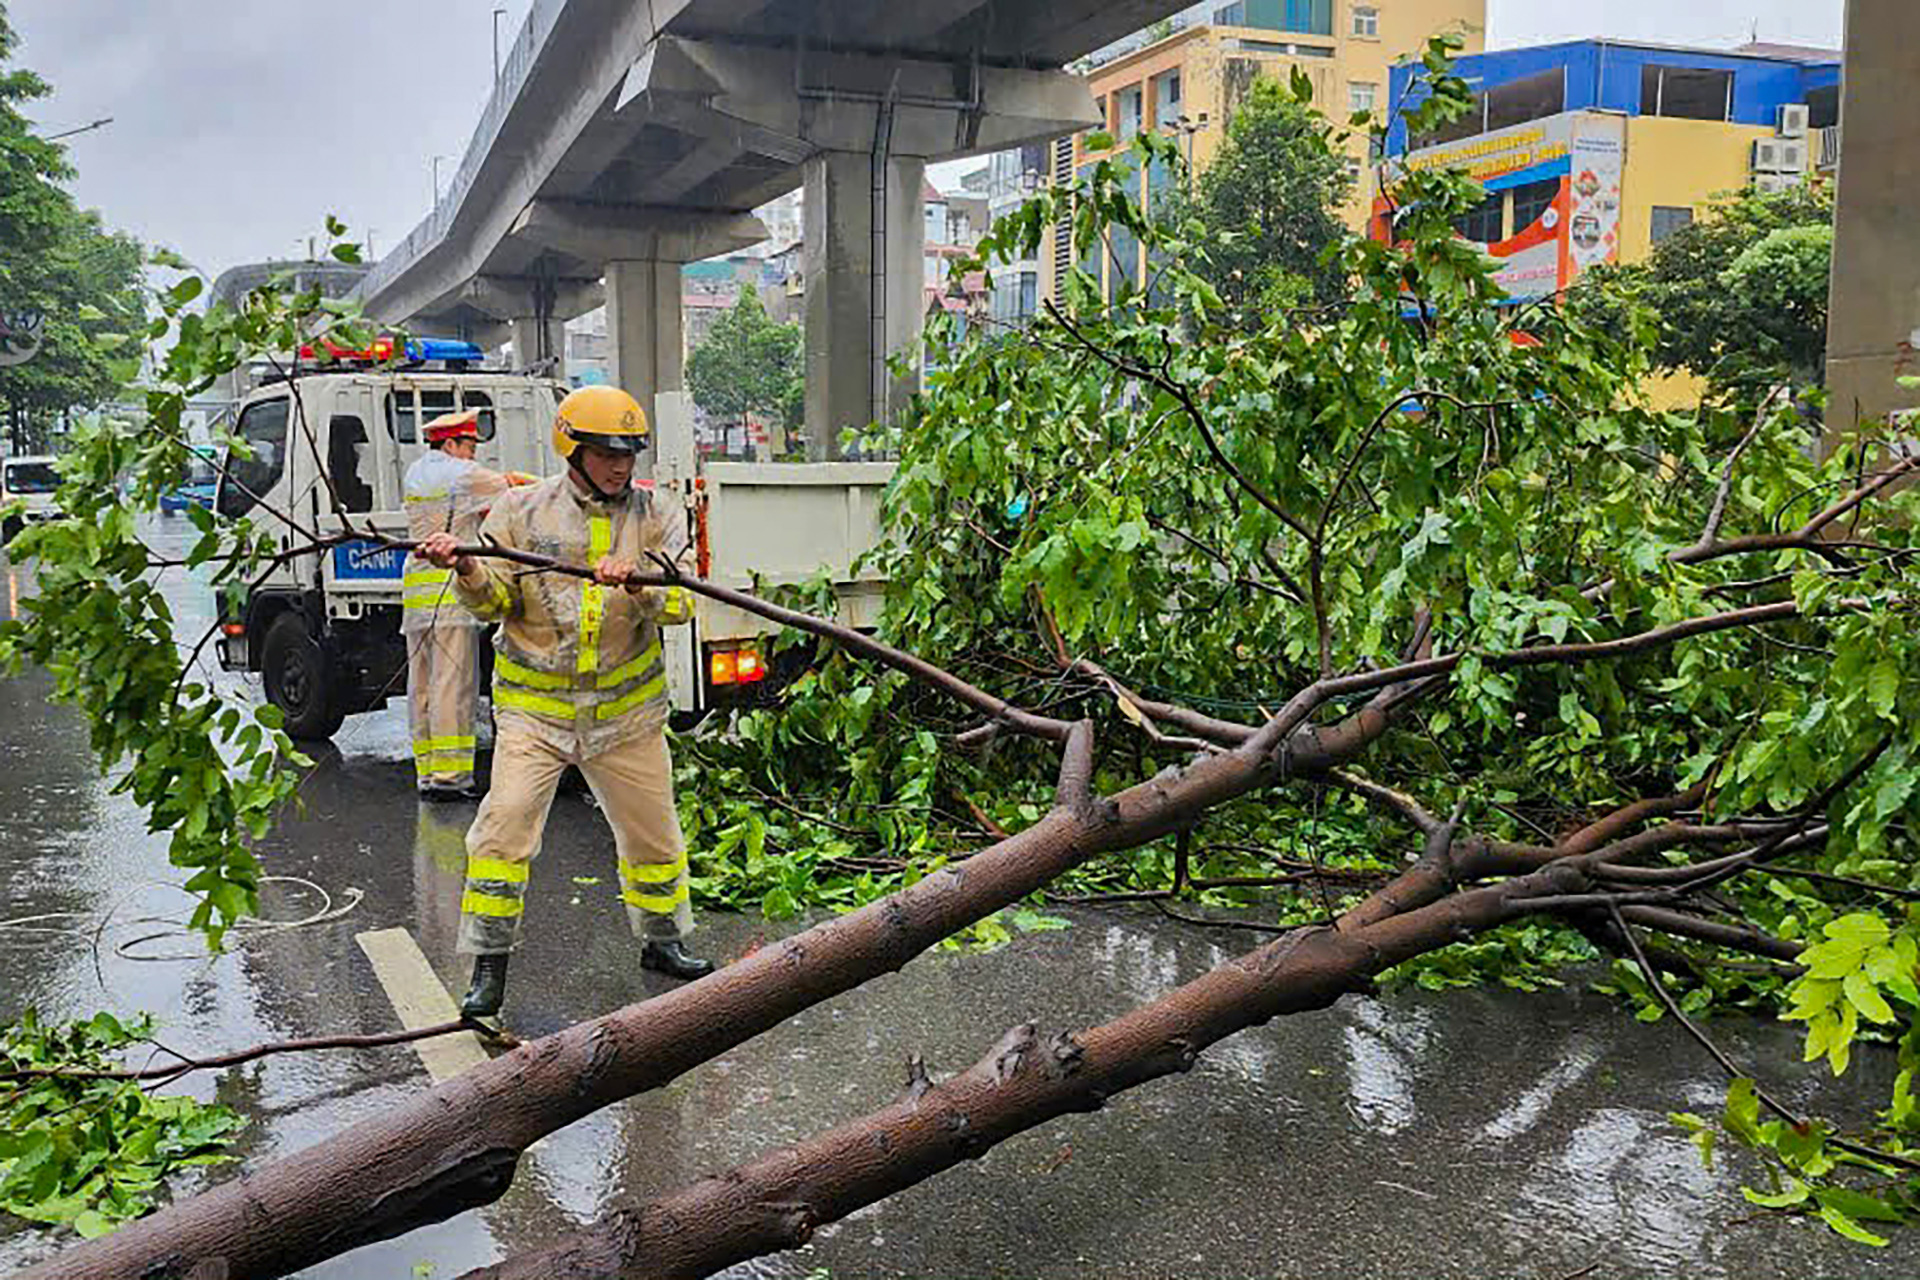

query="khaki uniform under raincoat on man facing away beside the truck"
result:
[399,449,507,787]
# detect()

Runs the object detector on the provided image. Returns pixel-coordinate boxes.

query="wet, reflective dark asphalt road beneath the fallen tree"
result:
[0,522,1920,1280]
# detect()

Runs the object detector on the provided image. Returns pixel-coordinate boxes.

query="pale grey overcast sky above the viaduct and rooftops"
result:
[6,0,1843,273]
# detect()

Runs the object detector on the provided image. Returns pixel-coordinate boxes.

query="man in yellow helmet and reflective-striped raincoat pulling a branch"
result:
[420,386,712,1017]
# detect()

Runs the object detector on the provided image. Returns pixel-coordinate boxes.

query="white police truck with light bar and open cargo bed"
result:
[213,351,893,739]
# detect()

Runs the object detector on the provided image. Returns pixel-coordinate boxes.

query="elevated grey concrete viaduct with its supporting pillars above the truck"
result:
[345,0,1183,457]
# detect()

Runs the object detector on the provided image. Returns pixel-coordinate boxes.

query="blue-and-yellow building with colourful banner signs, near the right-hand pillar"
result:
[1371,40,1839,301]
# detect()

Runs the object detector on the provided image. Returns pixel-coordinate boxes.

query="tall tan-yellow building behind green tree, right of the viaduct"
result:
[1067,0,1486,294]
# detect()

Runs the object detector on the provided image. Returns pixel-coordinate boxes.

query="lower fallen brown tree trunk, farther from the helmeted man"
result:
[465,825,1766,1280]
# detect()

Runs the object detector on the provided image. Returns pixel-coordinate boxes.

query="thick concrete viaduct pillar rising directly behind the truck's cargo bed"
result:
[806,152,927,461]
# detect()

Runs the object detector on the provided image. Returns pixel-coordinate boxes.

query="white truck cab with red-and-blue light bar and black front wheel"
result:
[213,344,566,739]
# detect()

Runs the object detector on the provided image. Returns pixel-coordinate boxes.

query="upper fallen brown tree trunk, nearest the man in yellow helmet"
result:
[23,706,1386,1280]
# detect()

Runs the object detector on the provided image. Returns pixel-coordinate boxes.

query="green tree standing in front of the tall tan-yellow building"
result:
[1162,77,1354,311]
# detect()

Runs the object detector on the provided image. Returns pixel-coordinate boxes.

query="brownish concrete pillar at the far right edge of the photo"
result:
[1826,0,1920,438]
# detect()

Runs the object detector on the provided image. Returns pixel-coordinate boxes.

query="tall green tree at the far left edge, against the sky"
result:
[0,4,144,451]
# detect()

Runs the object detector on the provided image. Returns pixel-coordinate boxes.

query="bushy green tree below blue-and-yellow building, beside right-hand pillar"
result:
[1574,182,1834,403]
